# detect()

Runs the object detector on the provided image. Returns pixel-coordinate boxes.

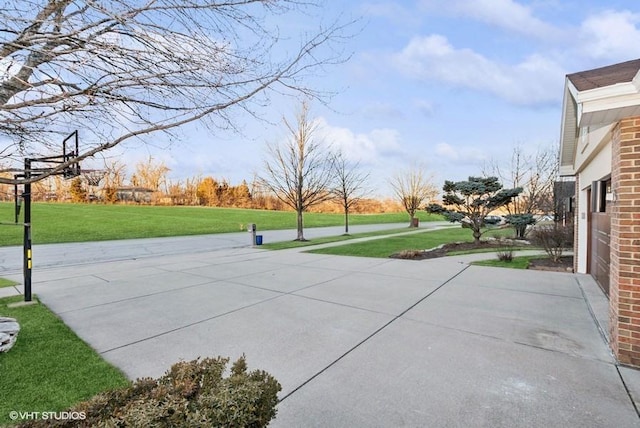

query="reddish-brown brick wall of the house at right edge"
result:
[609,117,640,367]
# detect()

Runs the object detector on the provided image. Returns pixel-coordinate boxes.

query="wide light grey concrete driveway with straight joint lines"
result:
[2,226,640,427]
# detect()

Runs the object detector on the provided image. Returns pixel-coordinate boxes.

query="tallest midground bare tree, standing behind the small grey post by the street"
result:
[258,101,333,241]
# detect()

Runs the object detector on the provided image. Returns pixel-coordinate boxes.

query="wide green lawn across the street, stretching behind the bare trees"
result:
[0,202,442,246]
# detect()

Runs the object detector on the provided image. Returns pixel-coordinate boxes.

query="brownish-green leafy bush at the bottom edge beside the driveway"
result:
[20,356,281,427]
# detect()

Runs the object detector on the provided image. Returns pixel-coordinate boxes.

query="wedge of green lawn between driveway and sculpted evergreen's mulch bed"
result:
[309,227,513,257]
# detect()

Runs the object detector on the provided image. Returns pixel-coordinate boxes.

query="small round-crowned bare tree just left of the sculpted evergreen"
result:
[391,165,438,227]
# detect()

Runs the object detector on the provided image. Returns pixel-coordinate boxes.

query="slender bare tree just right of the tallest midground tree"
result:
[331,151,370,233]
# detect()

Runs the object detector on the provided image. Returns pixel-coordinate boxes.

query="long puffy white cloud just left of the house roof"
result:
[393,34,565,105]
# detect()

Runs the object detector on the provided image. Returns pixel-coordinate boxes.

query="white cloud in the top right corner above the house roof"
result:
[578,10,640,61]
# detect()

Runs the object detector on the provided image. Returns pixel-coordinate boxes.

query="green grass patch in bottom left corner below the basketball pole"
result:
[0,296,129,426]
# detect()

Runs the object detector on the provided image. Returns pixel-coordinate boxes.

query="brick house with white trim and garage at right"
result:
[560,59,640,367]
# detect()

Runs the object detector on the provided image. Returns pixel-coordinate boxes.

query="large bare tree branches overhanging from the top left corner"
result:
[0,0,353,184]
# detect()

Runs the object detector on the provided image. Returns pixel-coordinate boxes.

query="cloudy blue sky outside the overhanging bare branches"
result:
[111,0,640,196]
